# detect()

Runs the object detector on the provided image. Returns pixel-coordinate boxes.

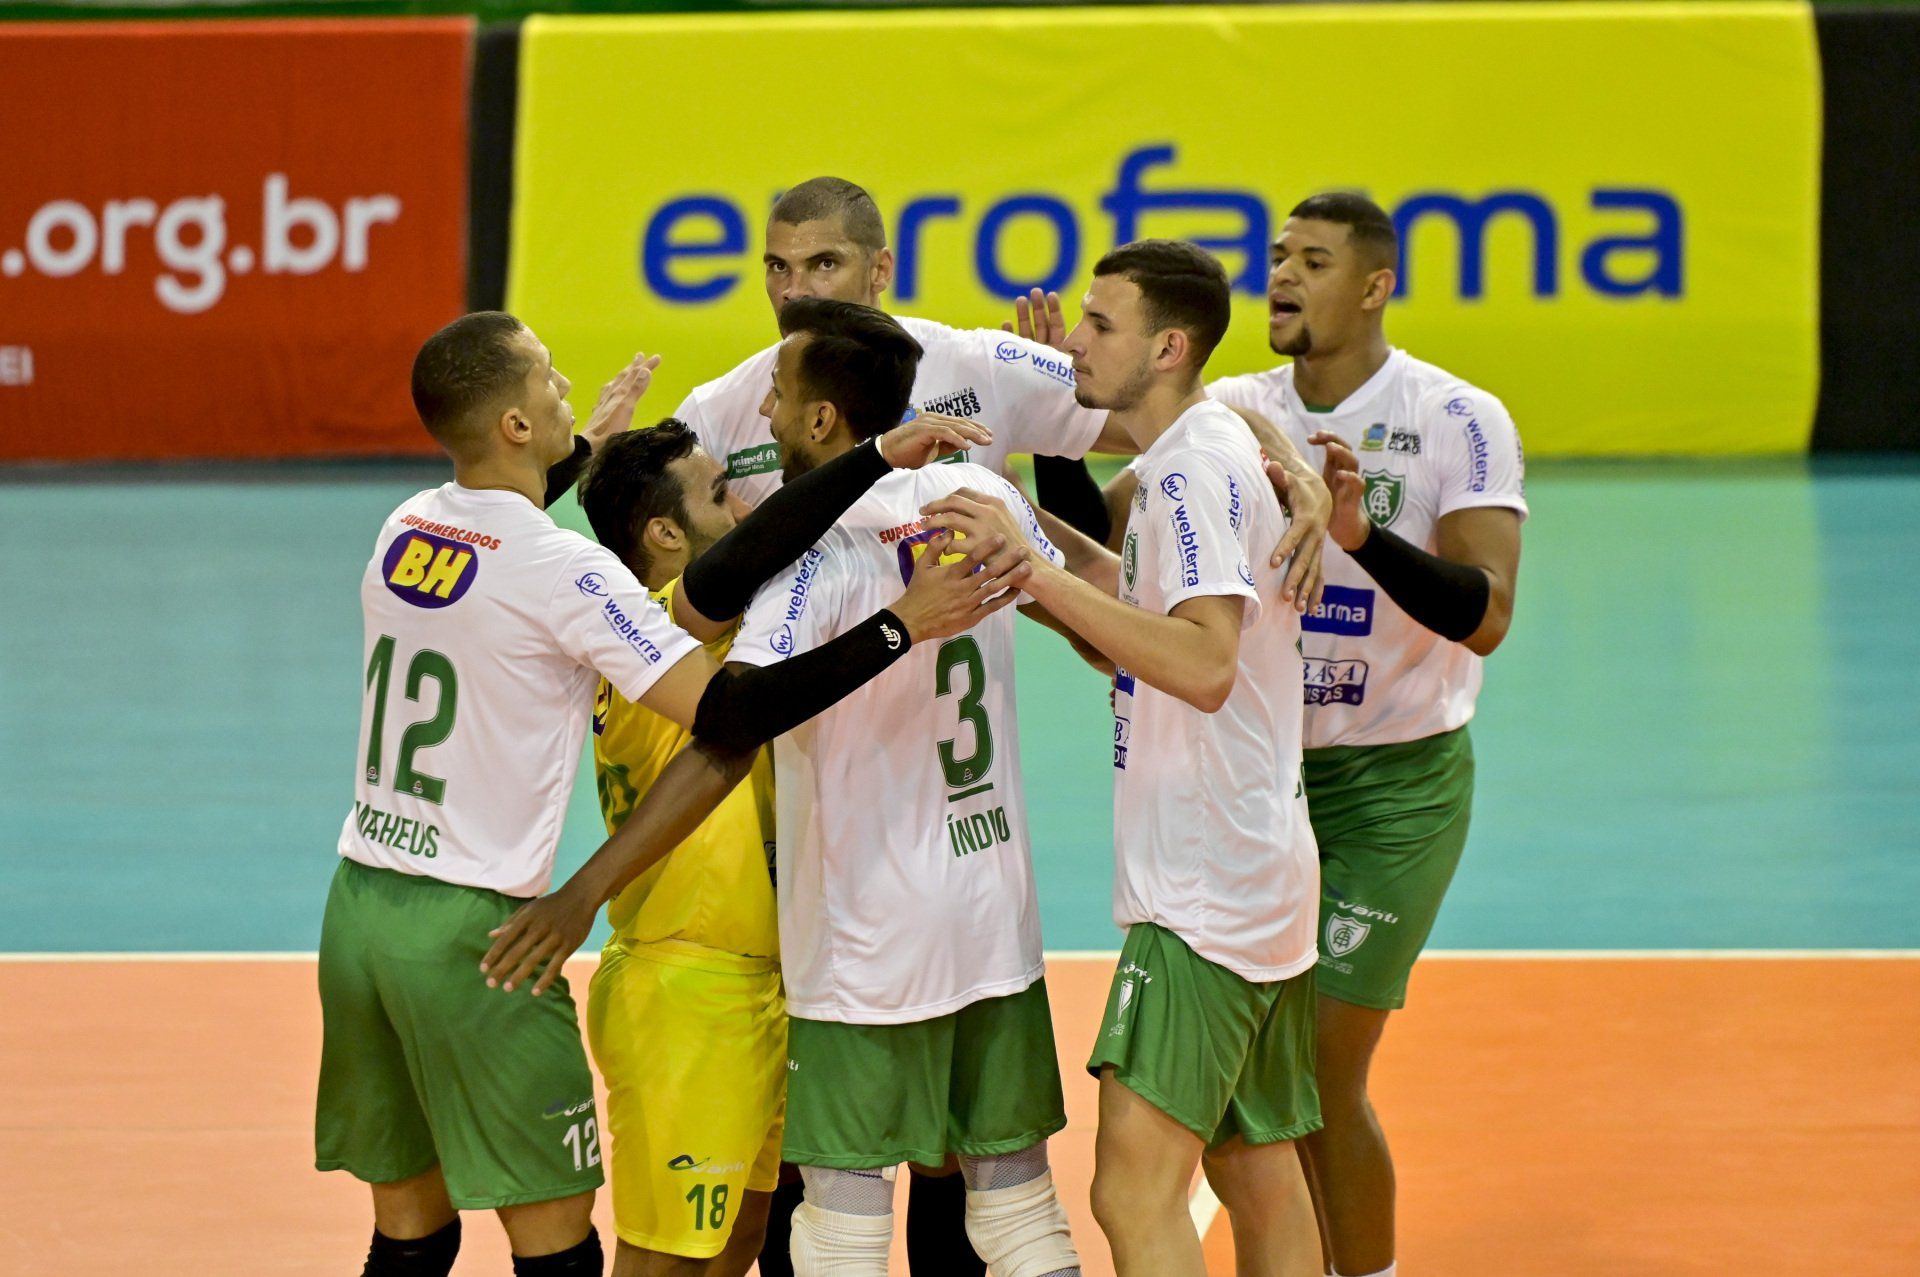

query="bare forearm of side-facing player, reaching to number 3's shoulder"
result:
[1025,566,1238,712]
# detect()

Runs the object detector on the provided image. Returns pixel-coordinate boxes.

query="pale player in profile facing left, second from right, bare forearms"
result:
[927,240,1319,1277]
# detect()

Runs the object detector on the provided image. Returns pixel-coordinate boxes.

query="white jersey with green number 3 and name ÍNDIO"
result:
[728,465,1058,1024]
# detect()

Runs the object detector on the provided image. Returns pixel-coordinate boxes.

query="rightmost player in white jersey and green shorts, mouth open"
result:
[1208,194,1526,1277]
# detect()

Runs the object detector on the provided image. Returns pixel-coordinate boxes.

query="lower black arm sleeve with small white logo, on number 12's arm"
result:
[693,609,912,753]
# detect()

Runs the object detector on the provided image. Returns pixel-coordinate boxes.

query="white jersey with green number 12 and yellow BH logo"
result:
[340,484,699,897]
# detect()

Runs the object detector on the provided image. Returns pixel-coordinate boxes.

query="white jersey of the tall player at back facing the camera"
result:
[676,317,1106,505]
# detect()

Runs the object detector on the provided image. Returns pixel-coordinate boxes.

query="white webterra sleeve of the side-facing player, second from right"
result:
[1146,453,1260,630]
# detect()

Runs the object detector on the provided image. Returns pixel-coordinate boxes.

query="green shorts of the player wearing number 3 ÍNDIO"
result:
[781,979,1068,1169]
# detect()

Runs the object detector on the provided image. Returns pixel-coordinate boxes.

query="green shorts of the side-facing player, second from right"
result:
[1087,922,1321,1148]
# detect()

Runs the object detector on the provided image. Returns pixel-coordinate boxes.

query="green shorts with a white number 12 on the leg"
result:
[313,860,605,1210]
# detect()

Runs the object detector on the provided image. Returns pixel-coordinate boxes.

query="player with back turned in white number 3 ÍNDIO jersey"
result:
[730,298,1079,1277]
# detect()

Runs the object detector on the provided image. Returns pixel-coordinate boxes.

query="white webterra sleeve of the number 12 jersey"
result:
[547,543,701,703]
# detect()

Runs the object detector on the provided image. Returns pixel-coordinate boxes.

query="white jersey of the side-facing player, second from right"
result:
[1114,399,1319,983]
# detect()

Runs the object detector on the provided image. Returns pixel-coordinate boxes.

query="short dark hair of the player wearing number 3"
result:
[780,298,920,440]
